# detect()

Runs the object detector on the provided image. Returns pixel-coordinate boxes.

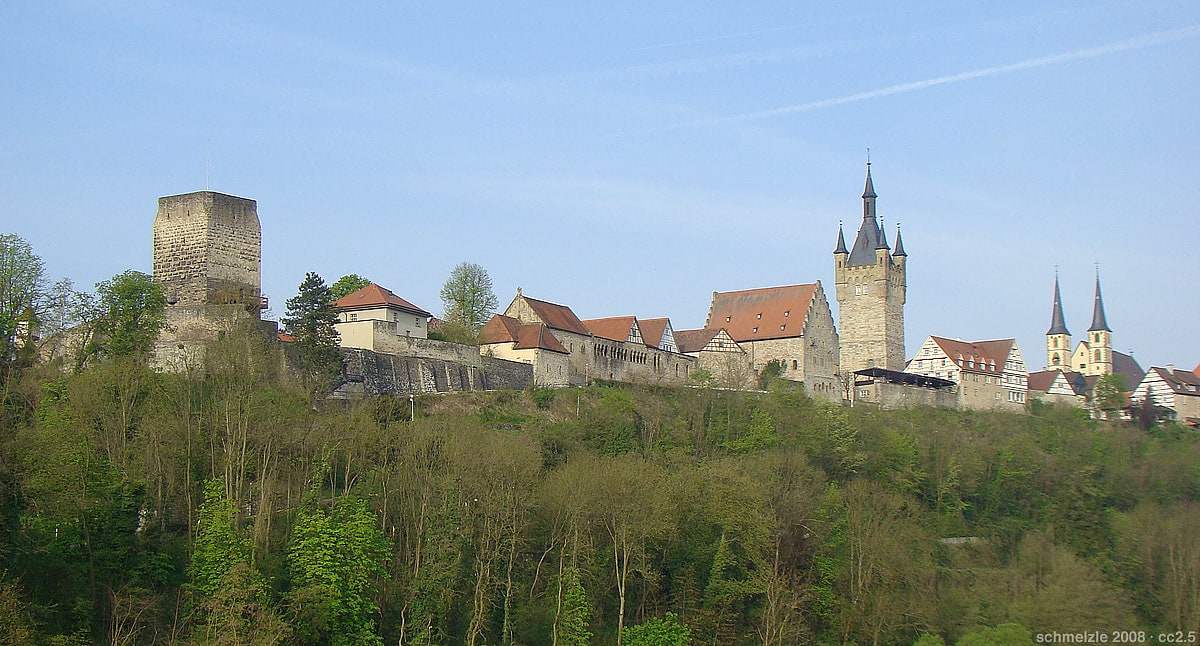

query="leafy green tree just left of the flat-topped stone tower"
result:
[92,269,167,357]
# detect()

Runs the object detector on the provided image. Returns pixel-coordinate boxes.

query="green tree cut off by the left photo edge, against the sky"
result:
[0,233,46,363]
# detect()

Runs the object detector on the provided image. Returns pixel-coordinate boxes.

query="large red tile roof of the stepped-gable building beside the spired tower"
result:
[700,283,817,342]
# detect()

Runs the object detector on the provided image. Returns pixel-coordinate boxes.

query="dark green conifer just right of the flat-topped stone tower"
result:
[283,271,342,385]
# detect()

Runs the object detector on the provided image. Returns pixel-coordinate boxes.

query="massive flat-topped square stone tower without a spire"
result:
[152,191,266,370]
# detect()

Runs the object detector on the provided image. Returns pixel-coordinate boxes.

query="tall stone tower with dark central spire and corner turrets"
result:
[833,161,908,375]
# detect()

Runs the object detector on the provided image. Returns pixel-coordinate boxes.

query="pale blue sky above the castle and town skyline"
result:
[0,0,1200,370]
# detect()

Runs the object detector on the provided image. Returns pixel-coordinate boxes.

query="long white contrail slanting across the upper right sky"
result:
[688,25,1200,126]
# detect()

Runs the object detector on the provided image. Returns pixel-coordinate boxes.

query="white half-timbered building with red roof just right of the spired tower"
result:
[905,336,1028,411]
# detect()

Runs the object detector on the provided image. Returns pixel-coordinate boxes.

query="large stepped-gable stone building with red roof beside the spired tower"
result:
[704,281,842,401]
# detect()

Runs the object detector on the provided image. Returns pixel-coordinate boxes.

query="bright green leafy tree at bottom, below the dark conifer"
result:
[288,489,391,646]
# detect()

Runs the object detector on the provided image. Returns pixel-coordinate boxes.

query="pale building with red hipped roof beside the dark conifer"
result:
[334,282,433,351]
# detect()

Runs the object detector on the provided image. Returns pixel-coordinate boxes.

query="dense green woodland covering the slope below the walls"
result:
[0,321,1200,645]
